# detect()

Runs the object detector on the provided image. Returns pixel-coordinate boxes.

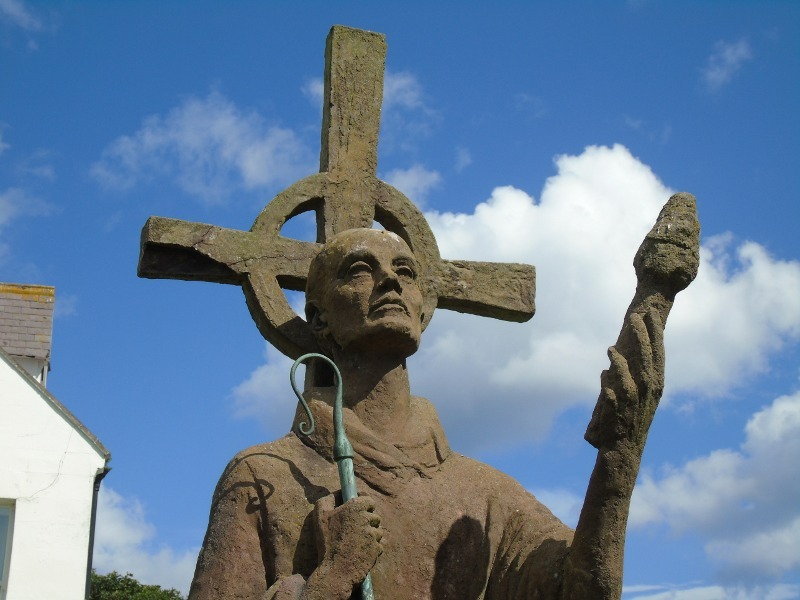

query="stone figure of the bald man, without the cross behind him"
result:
[189,198,700,600]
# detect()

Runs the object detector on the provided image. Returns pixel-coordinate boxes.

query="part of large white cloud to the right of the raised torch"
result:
[667,236,800,396]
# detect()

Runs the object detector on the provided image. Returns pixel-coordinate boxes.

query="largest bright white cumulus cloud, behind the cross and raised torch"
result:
[223,146,800,454]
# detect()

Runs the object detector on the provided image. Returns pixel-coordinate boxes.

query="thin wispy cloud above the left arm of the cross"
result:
[91,92,315,204]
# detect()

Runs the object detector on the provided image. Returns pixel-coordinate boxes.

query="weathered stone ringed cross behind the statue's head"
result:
[138,26,535,358]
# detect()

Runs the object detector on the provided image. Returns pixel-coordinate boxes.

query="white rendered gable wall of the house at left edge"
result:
[0,357,105,600]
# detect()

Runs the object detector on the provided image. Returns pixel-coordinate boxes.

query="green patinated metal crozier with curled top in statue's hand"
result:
[289,352,375,600]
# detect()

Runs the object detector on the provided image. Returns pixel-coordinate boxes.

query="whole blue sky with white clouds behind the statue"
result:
[0,0,800,600]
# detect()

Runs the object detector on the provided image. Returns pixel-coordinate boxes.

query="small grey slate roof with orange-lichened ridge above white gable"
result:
[0,283,56,363]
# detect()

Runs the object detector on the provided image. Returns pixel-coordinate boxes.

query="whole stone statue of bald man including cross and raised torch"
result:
[139,27,699,600]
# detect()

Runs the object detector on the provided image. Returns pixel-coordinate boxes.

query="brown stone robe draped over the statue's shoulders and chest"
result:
[189,396,572,600]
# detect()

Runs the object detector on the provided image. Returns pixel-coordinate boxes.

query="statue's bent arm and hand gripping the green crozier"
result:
[189,451,383,600]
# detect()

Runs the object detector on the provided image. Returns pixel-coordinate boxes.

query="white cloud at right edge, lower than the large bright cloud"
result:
[629,392,800,577]
